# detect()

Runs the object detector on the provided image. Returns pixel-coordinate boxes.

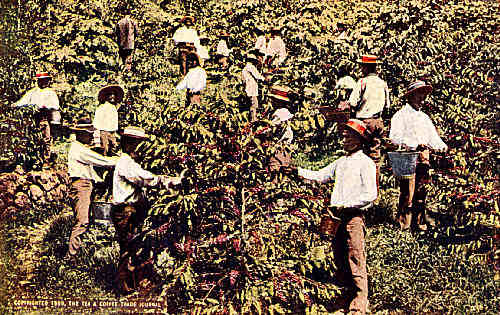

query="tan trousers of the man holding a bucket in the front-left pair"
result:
[69,178,94,255]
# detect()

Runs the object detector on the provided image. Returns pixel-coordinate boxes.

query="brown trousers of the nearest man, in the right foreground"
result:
[333,215,368,314]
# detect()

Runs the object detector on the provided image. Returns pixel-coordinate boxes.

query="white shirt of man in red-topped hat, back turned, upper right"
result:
[349,73,391,118]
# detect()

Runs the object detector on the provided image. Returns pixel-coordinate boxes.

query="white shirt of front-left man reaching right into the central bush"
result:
[113,153,160,205]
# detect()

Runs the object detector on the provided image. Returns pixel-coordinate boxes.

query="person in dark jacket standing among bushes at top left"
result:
[115,8,138,70]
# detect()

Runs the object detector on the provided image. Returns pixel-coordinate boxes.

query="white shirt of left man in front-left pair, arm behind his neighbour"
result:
[68,140,118,182]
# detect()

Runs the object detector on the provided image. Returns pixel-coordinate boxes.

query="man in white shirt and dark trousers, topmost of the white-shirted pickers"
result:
[173,16,200,75]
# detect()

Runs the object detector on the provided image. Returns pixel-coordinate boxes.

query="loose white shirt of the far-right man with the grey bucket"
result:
[389,104,448,150]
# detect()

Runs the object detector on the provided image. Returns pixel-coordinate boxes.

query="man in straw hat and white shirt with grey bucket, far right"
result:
[389,81,448,230]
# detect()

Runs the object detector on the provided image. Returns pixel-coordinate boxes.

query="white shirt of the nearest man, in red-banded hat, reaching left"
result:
[298,150,377,209]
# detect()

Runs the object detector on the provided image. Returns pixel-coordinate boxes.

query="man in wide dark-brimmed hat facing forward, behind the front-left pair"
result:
[93,85,123,155]
